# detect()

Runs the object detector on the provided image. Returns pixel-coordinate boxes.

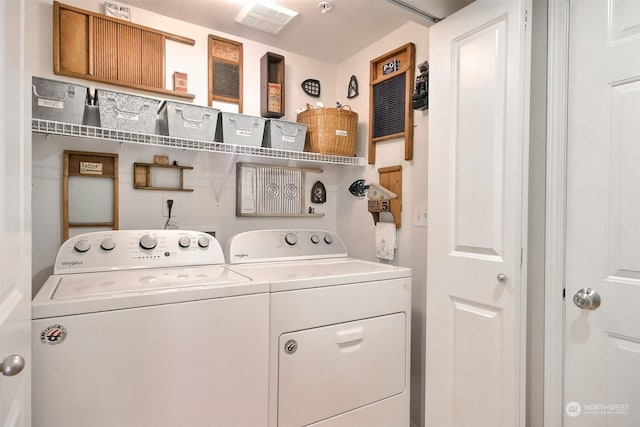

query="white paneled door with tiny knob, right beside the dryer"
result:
[425,0,530,427]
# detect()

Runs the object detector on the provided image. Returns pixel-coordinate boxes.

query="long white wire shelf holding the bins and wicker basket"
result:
[31,119,365,166]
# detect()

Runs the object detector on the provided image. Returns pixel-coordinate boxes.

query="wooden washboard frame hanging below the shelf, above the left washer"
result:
[62,150,119,240]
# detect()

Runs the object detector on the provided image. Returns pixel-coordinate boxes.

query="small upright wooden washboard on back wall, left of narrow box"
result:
[207,34,243,113]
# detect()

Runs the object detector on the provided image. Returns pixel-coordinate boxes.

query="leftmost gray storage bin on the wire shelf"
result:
[31,77,89,125]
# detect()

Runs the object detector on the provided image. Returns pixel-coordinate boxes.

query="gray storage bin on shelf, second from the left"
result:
[95,89,160,134]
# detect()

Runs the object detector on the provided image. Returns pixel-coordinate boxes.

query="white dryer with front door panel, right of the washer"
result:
[226,230,411,427]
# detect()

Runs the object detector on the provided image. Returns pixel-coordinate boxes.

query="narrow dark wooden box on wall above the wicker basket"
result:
[260,52,284,119]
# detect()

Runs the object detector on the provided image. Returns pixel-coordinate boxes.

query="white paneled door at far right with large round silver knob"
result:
[563,0,640,427]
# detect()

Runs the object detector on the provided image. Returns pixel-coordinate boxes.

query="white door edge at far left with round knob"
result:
[0,0,31,427]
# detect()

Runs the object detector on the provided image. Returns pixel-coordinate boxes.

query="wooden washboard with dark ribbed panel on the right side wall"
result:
[368,43,416,165]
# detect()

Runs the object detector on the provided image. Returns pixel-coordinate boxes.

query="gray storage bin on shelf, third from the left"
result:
[158,101,220,141]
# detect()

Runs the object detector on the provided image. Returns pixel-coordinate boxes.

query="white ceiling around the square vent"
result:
[123,0,473,63]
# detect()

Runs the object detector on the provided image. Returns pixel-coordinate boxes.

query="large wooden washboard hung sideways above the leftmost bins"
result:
[53,1,195,99]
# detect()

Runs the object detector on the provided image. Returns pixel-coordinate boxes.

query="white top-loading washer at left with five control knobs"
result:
[32,230,269,427]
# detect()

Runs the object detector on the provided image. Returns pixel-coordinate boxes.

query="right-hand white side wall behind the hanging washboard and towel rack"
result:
[337,22,429,426]
